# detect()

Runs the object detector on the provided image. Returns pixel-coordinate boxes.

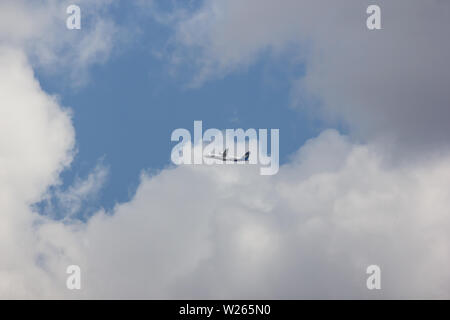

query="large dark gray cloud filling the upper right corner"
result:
[167,0,450,152]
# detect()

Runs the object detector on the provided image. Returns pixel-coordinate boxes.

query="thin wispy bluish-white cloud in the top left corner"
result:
[0,0,122,86]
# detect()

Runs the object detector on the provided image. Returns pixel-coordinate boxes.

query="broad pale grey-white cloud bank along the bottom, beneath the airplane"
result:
[22,131,450,298]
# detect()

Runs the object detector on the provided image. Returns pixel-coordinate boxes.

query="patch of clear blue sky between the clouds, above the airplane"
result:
[36,2,323,211]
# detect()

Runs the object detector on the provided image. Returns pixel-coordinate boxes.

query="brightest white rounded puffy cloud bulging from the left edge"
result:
[0,47,74,202]
